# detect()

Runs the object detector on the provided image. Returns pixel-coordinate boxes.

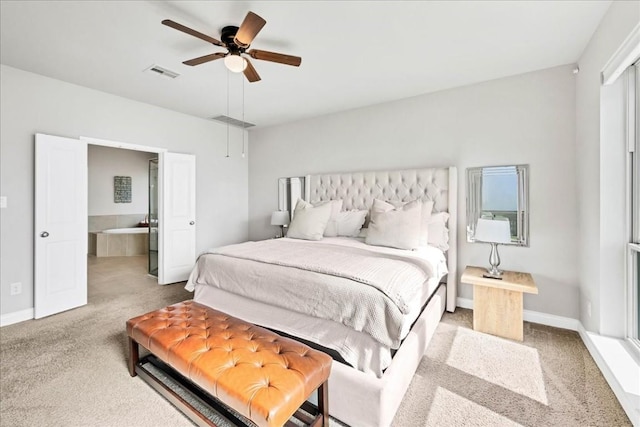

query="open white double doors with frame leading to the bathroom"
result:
[34,134,196,319]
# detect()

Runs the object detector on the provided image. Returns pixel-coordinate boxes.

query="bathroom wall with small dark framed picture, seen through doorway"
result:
[87,144,158,217]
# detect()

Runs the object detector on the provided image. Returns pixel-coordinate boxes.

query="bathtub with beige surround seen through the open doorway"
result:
[89,227,149,257]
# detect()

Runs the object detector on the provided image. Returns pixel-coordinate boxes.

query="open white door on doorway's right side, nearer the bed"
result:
[158,153,196,285]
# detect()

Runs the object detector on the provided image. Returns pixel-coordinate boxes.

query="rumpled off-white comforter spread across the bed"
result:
[187,238,446,348]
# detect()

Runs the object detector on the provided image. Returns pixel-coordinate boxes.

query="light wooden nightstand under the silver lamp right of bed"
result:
[460,267,538,341]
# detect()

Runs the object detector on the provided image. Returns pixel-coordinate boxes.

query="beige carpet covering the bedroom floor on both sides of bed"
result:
[0,257,631,427]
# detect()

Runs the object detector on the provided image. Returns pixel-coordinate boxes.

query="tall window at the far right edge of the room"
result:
[626,63,640,351]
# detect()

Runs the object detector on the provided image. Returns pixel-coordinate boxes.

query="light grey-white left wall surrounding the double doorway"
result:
[0,65,248,315]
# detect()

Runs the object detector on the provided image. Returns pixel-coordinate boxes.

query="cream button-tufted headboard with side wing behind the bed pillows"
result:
[305,167,458,311]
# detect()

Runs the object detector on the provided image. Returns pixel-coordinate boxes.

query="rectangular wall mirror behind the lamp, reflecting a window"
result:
[467,165,529,246]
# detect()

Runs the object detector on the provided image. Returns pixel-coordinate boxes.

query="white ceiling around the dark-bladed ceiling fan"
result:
[0,0,611,126]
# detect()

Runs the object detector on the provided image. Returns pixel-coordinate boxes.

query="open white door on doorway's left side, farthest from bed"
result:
[34,134,88,319]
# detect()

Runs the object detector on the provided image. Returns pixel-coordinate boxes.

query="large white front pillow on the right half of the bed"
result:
[365,199,422,249]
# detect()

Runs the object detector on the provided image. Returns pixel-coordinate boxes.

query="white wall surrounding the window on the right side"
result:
[576,1,640,336]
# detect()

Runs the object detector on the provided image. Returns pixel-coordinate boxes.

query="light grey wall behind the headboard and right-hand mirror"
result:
[249,65,579,318]
